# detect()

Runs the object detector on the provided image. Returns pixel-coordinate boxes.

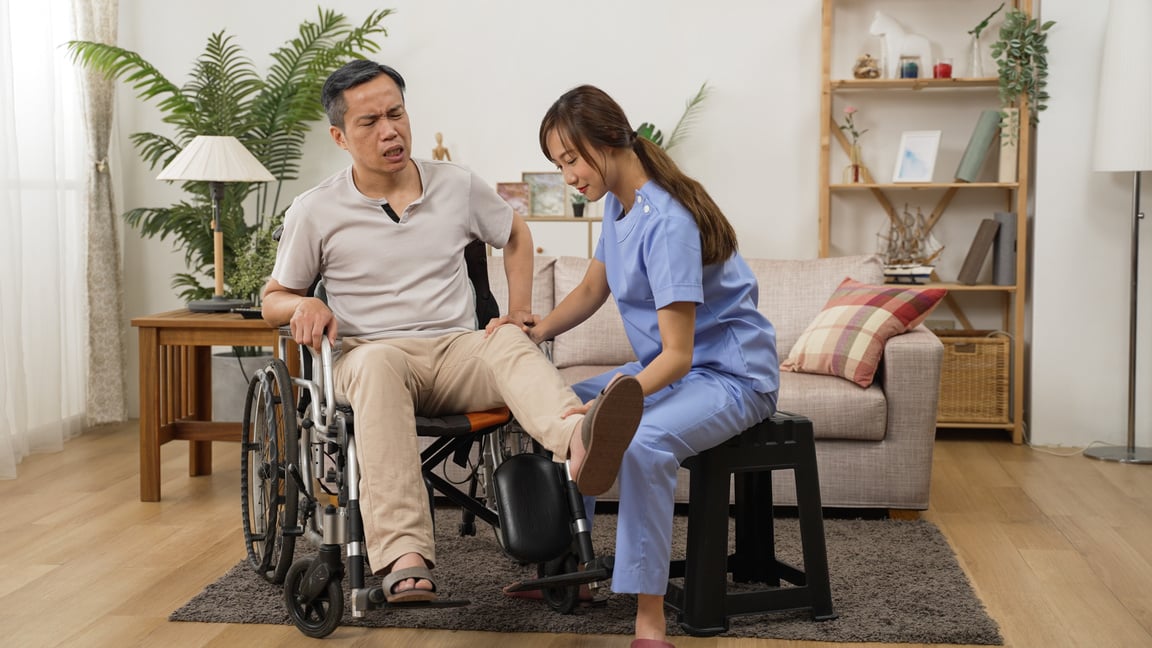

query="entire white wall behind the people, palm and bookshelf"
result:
[118,0,1152,445]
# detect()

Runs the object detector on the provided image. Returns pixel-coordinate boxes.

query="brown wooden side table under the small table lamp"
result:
[132,309,298,502]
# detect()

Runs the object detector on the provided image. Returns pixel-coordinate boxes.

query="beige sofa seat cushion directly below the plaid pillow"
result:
[776,372,888,440]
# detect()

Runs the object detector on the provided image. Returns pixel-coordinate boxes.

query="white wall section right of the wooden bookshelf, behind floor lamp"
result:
[1031,0,1152,447]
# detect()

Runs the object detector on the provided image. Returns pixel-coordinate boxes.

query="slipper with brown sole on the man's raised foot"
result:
[575,376,644,496]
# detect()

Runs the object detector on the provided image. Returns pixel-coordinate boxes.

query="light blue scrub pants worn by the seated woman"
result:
[573,362,776,596]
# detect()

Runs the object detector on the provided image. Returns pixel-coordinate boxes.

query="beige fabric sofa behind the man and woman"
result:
[488,256,943,510]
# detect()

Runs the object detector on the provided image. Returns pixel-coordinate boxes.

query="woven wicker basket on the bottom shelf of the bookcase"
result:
[935,331,1011,423]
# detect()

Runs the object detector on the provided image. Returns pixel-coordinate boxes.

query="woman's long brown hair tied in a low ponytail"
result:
[540,85,736,265]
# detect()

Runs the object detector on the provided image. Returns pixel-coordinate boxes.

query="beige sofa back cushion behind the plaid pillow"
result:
[748,255,884,357]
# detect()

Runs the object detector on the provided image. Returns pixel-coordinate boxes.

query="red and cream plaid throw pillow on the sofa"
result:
[780,274,948,387]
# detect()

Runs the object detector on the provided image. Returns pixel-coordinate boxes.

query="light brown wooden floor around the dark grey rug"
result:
[0,422,1152,648]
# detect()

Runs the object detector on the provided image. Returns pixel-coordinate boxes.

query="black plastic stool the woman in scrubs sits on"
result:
[665,412,836,636]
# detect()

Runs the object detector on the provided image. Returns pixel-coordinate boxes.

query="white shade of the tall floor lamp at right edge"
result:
[1092,0,1152,171]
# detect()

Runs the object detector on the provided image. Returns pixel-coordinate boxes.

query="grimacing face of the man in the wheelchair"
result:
[329,75,412,173]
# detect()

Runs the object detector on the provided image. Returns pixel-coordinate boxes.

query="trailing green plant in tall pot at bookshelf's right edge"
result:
[992,9,1056,182]
